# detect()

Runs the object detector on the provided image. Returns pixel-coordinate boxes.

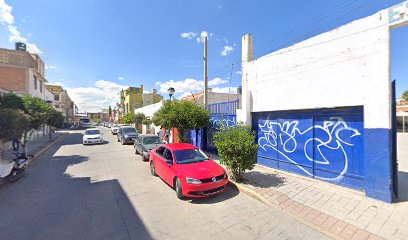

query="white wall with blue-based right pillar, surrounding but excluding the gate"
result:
[241,1,408,202]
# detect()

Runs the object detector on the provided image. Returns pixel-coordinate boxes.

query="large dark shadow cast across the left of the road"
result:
[0,133,151,240]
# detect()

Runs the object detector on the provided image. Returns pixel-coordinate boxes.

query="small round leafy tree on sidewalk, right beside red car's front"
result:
[214,124,258,181]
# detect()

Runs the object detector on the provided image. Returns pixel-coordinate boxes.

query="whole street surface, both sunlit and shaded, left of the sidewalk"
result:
[0,128,326,240]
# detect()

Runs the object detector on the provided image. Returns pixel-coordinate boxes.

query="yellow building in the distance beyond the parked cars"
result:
[120,85,163,116]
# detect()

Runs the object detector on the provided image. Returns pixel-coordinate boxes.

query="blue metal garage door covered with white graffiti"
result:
[252,107,364,189]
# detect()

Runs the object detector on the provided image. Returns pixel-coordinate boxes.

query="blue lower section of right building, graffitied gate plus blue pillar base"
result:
[252,107,396,202]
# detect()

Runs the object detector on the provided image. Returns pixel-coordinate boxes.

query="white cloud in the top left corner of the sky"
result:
[0,0,42,54]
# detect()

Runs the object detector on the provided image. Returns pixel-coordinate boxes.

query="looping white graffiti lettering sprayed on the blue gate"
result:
[258,120,361,181]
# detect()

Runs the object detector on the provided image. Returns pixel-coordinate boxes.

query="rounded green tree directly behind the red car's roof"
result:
[152,100,210,142]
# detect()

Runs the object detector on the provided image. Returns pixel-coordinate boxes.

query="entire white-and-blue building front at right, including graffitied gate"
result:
[237,1,408,202]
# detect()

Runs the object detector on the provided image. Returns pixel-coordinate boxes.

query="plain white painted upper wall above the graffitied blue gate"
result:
[242,8,391,128]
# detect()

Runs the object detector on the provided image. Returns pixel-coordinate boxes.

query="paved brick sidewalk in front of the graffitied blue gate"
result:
[210,134,408,239]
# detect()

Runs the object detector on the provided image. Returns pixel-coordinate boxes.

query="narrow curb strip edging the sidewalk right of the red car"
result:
[229,178,343,240]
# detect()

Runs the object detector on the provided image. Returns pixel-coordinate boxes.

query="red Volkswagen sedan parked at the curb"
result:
[150,143,228,198]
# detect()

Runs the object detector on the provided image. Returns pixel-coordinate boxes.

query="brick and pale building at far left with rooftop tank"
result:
[0,45,53,101]
